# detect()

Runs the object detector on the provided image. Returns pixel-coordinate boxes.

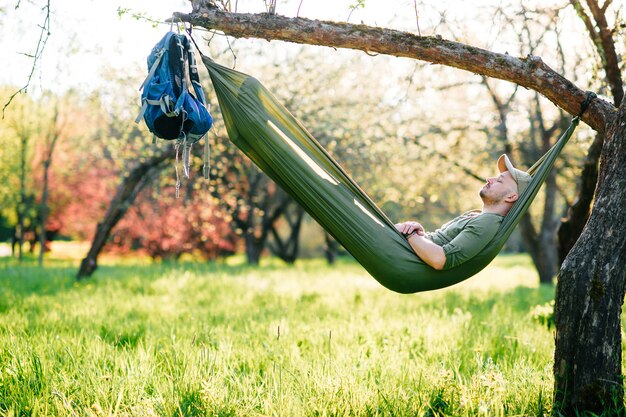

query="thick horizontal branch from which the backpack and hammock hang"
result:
[174,6,617,131]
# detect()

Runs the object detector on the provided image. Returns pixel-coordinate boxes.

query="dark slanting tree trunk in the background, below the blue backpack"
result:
[76,150,169,280]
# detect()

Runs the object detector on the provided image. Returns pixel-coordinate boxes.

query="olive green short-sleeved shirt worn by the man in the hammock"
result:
[426,211,504,269]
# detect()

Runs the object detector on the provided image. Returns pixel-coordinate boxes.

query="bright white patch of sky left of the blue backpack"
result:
[0,0,189,89]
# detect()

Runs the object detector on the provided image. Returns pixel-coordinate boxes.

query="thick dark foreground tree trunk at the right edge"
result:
[554,96,626,415]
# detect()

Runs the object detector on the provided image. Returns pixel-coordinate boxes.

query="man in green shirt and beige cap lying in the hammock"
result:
[396,155,531,269]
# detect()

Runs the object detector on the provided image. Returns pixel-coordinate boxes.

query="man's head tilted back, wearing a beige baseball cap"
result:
[480,155,531,212]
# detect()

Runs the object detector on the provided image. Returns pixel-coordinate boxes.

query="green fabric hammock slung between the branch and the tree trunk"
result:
[202,56,579,293]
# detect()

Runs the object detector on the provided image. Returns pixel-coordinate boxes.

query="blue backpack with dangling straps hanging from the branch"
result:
[135,31,213,178]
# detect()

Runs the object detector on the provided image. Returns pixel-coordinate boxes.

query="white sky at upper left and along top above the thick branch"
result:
[0,0,516,92]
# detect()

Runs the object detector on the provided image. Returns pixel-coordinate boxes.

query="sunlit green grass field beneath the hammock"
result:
[0,256,554,417]
